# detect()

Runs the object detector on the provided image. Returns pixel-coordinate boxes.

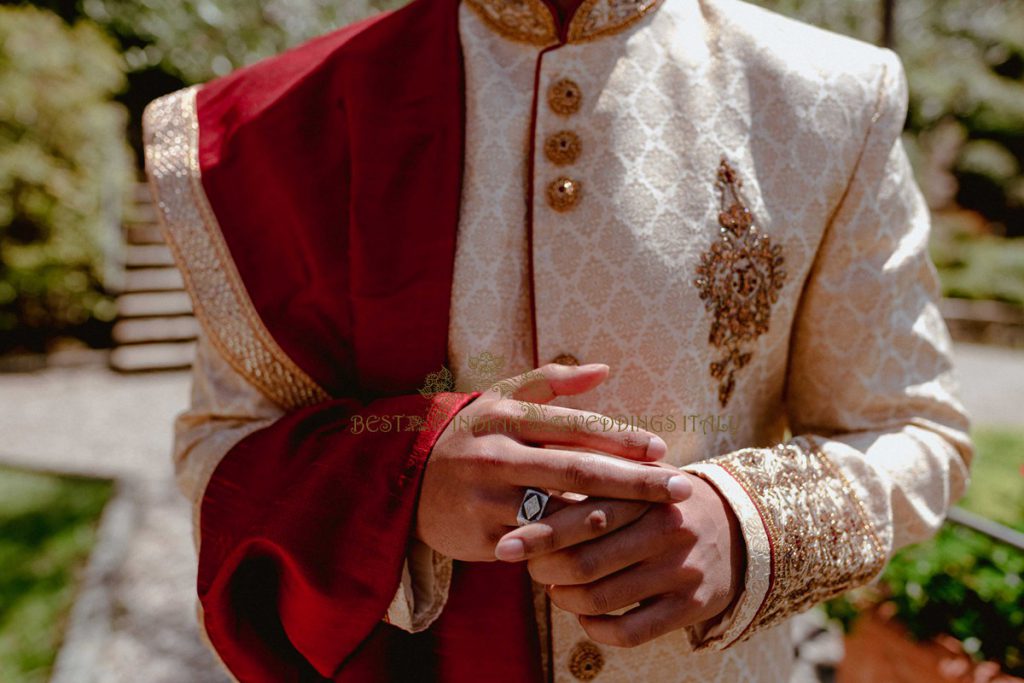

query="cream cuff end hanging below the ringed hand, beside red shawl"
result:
[386,540,452,633]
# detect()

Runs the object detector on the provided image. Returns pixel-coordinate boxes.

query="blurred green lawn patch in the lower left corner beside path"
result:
[0,469,112,683]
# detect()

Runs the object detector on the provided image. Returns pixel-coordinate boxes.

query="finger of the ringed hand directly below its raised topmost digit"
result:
[517,405,669,461]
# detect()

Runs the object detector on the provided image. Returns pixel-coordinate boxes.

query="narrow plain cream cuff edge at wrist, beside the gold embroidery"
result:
[682,463,771,649]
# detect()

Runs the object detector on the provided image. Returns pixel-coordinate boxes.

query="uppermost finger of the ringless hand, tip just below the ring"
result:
[495,498,649,562]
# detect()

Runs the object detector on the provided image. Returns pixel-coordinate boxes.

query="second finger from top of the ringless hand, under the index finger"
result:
[529,506,692,586]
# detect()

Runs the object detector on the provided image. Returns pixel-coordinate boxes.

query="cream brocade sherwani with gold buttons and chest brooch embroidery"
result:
[175,0,972,683]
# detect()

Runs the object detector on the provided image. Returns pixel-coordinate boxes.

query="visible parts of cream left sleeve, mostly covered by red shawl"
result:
[174,333,452,632]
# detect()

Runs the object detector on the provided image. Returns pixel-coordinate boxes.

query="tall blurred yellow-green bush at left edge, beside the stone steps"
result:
[0,7,131,347]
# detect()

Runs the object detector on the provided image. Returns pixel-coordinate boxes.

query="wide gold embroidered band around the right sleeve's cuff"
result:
[714,436,887,640]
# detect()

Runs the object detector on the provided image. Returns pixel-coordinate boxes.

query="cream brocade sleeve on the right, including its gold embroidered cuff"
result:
[686,50,973,649]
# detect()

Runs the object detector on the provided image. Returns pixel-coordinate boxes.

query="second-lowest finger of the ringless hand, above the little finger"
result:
[548,560,699,615]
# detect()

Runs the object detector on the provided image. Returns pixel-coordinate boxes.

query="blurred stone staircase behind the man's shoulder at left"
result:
[111,183,199,373]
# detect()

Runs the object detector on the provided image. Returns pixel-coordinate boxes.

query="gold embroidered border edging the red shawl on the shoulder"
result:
[143,87,329,410]
